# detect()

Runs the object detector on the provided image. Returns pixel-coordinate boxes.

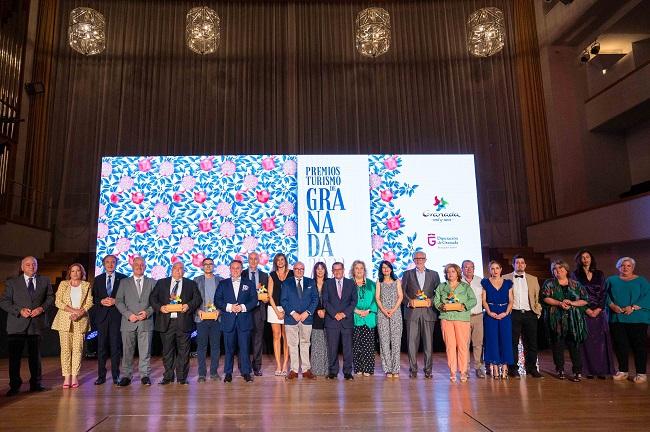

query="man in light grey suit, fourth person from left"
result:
[115,257,156,387]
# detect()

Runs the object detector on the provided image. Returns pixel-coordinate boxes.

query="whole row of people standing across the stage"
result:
[0,250,650,395]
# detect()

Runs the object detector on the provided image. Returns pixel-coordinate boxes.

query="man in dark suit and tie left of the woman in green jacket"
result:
[323,262,357,380]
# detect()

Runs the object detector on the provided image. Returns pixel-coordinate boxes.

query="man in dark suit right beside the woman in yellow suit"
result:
[93,255,126,385]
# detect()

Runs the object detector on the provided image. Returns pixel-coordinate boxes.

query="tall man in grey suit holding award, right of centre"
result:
[402,251,440,379]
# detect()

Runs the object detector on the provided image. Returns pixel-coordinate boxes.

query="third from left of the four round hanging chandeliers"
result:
[356,7,390,58]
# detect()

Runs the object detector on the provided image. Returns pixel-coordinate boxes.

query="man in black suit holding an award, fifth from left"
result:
[149,261,202,385]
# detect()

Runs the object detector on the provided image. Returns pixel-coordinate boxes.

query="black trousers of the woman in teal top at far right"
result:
[609,323,648,374]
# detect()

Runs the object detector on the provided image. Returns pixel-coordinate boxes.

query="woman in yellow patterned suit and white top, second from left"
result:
[52,263,93,389]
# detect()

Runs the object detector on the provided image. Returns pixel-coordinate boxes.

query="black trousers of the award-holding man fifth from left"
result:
[160,318,191,381]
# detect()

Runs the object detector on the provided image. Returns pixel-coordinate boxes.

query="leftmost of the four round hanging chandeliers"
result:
[68,7,106,56]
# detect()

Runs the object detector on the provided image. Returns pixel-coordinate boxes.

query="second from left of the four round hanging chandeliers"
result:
[185,6,221,54]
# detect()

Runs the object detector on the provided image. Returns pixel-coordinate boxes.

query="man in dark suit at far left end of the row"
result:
[0,256,54,396]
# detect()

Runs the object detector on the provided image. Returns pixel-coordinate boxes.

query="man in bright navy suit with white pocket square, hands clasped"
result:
[214,260,257,382]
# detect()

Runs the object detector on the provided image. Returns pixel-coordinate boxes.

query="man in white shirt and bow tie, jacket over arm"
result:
[503,255,542,378]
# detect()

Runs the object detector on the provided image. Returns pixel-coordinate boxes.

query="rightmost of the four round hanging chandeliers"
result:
[467,7,506,57]
